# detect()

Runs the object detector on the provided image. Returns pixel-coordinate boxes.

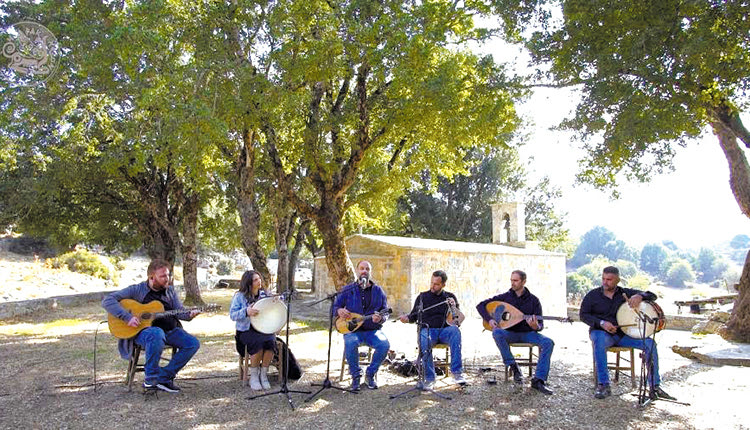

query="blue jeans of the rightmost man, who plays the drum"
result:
[589,330,661,387]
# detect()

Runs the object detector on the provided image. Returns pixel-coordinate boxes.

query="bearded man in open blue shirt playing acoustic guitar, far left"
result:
[102,259,200,393]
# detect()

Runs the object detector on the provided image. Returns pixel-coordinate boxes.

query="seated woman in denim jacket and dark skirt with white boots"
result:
[229,270,276,390]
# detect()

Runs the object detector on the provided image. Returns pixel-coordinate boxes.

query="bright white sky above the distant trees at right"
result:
[519,88,750,249]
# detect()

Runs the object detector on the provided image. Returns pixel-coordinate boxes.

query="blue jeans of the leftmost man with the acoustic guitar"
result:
[135,327,200,384]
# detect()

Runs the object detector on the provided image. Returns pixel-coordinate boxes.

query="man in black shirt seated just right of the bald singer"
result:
[399,270,466,389]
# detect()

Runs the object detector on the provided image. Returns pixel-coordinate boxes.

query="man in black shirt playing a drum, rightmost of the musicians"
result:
[580,266,674,399]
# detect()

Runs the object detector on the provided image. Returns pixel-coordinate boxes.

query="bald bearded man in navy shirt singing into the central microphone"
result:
[333,261,391,391]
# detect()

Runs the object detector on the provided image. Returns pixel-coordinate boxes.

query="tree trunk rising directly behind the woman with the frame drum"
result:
[237,130,271,285]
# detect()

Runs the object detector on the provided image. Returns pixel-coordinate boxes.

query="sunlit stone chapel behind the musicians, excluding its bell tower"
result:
[315,235,566,318]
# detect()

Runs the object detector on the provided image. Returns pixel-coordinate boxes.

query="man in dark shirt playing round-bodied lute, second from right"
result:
[477,270,555,394]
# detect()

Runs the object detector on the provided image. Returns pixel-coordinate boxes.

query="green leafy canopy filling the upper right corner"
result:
[494,0,750,188]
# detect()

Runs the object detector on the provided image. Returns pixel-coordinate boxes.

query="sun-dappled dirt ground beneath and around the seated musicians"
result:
[0,290,750,429]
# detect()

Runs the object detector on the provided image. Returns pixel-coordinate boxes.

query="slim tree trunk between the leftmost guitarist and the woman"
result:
[180,195,205,306]
